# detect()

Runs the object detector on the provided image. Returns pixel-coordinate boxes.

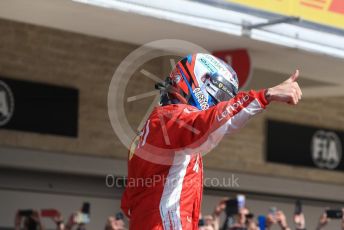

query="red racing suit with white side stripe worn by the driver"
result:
[121,90,268,230]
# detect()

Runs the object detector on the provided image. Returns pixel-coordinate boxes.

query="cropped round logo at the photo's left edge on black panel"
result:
[0,80,14,127]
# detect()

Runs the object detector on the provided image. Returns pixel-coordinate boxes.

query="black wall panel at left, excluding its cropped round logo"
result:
[0,76,79,137]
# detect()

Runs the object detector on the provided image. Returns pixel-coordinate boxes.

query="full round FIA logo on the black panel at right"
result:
[311,130,342,169]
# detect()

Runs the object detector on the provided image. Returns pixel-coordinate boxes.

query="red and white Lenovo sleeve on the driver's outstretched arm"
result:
[145,90,268,152]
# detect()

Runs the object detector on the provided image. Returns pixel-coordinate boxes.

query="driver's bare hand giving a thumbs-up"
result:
[266,70,302,105]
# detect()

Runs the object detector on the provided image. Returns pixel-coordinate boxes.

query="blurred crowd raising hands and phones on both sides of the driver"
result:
[15,198,344,230]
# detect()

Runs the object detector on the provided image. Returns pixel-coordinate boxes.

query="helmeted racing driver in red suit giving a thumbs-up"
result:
[121,53,302,230]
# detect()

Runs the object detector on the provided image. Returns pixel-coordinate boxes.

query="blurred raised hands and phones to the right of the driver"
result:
[199,198,344,230]
